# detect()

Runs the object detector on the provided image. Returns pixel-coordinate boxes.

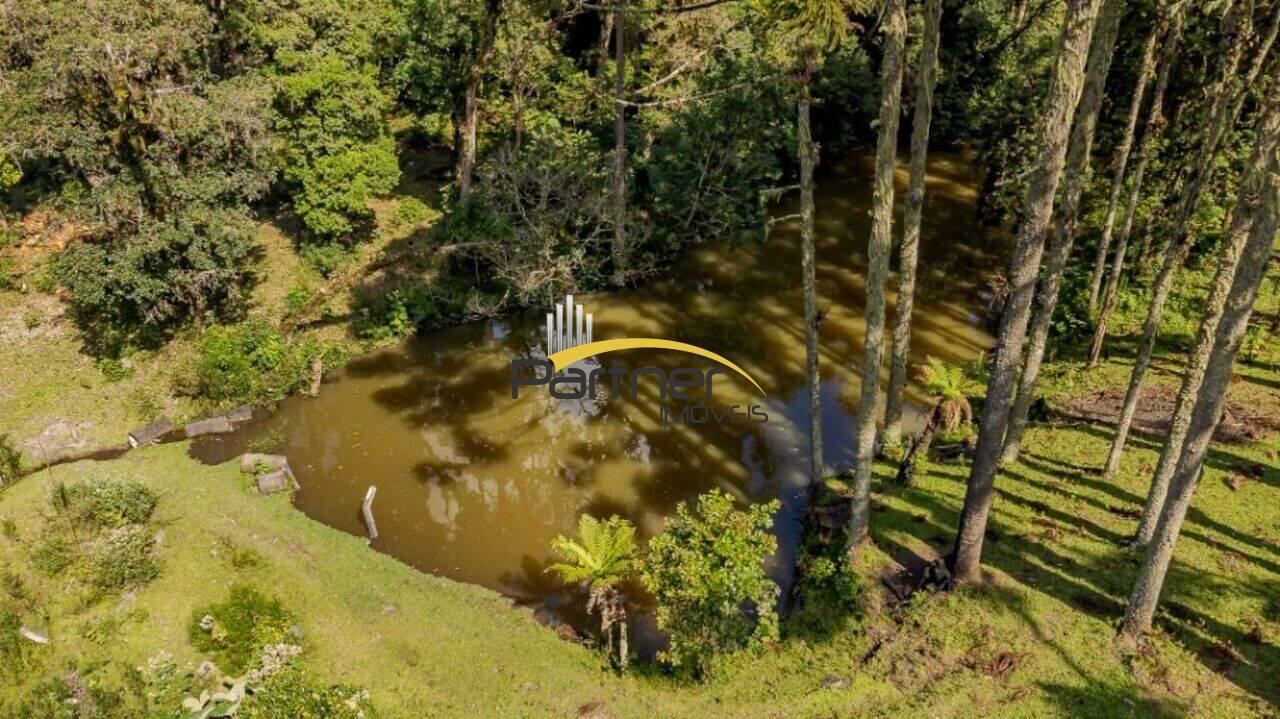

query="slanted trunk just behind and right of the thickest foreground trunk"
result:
[1001,0,1125,462]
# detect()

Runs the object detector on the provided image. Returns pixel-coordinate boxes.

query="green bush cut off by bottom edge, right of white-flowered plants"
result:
[237,665,378,719]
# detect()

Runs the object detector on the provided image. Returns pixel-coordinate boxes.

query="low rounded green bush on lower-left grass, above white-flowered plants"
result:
[187,585,293,674]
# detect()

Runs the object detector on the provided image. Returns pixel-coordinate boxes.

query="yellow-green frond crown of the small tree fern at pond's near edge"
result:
[547,514,636,589]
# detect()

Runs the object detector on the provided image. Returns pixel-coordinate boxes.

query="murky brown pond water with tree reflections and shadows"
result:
[193,154,997,647]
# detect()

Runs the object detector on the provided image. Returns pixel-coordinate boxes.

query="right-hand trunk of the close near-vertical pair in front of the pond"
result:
[884,0,942,444]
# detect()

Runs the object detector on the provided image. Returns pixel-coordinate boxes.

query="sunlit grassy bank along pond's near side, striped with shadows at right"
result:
[0,372,1280,716]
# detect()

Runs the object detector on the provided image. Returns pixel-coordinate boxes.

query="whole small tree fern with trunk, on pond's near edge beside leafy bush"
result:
[547,514,636,672]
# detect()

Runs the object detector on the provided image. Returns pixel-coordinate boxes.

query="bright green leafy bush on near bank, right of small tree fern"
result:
[640,490,778,674]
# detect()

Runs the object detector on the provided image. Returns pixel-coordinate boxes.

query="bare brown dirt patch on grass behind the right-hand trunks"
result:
[1056,383,1280,444]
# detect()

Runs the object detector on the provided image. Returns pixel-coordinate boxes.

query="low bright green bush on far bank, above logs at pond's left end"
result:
[192,320,340,404]
